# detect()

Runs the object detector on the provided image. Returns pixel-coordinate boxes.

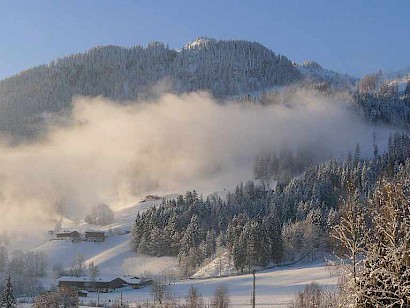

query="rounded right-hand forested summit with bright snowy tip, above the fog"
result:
[173,38,301,98]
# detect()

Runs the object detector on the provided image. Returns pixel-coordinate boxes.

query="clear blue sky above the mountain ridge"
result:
[0,0,410,78]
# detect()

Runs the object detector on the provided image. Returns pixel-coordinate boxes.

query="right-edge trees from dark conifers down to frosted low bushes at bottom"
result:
[293,135,410,308]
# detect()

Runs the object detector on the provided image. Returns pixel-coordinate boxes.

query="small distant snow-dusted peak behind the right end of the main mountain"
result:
[295,61,358,89]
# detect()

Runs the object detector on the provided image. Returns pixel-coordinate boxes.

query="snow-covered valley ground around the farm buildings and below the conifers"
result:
[19,195,336,307]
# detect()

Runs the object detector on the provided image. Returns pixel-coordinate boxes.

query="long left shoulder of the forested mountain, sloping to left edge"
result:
[0,43,176,136]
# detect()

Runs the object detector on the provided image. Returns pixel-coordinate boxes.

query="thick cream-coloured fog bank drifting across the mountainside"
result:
[0,91,391,236]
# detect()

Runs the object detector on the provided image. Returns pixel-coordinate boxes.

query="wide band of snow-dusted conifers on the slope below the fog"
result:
[132,134,410,275]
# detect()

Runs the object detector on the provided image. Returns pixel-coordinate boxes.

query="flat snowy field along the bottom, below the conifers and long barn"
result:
[71,263,337,307]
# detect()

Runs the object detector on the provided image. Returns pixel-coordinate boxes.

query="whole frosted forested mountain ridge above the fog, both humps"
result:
[0,38,301,137]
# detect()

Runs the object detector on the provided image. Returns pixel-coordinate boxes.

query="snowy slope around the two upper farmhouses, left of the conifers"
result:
[33,195,177,284]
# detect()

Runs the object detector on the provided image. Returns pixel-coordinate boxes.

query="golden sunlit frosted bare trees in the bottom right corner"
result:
[334,160,410,307]
